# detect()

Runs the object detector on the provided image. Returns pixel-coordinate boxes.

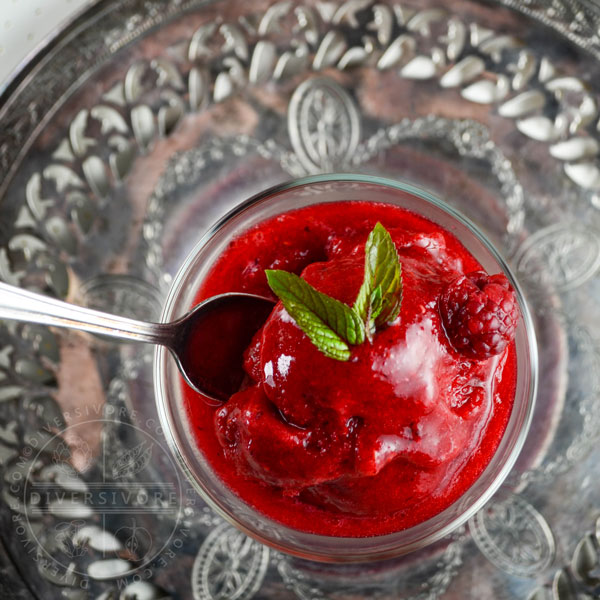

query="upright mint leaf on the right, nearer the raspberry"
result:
[353,223,402,331]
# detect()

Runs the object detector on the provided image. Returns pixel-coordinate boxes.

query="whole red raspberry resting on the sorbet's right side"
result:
[439,271,519,360]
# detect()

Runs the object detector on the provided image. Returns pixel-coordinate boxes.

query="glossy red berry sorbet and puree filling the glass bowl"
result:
[181,202,518,537]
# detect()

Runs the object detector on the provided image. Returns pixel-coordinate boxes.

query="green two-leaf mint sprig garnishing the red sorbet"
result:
[265,223,402,361]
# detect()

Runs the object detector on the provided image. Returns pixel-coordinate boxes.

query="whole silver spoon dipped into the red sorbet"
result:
[0,282,275,401]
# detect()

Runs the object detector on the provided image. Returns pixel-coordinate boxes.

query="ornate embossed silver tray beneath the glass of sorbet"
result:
[0,0,600,600]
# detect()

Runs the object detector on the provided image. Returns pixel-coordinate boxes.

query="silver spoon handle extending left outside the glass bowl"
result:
[0,282,173,345]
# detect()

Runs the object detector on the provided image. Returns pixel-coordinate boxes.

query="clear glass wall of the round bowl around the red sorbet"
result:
[154,174,537,562]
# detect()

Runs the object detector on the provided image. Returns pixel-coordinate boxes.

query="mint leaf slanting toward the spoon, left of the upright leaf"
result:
[265,269,365,360]
